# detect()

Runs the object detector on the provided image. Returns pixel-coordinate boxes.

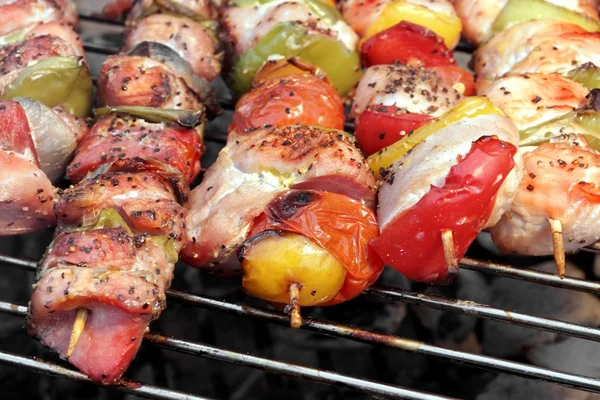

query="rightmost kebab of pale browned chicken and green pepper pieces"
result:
[457,0,600,277]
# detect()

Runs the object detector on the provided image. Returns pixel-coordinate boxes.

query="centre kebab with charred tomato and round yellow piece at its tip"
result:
[182,2,383,327]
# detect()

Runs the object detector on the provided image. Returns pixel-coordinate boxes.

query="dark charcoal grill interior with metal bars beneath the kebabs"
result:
[0,1,600,399]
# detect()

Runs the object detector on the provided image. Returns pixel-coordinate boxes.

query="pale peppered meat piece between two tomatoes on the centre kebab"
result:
[182,125,375,273]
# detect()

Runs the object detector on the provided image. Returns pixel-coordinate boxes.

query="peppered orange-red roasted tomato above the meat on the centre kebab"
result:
[229,74,345,132]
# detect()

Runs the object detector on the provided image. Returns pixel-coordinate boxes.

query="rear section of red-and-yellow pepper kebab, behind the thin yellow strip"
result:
[340,0,474,155]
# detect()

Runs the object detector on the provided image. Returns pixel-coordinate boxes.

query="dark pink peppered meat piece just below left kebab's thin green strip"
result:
[67,114,203,185]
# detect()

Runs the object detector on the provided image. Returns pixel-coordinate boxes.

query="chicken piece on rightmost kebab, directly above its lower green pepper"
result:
[484,74,588,145]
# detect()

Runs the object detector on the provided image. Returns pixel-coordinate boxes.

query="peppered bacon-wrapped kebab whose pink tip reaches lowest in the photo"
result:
[28,0,220,384]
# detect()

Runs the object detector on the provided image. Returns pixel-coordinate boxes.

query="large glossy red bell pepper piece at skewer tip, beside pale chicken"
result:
[371,136,517,282]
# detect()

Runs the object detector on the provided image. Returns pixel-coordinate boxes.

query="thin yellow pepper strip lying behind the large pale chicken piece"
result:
[367,96,504,178]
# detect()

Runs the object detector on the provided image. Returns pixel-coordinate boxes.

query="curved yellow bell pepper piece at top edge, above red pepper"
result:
[359,0,462,49]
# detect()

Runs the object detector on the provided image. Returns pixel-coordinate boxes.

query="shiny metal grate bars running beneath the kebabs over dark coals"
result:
[0,9,600,400]
